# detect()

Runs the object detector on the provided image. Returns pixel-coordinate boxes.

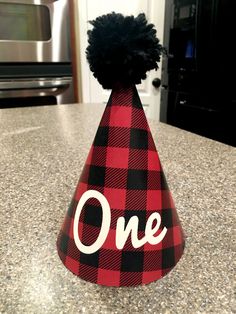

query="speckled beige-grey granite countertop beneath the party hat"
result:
[0,104,236,314]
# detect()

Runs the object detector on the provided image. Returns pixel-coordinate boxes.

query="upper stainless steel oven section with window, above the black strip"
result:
[0,0,70,62]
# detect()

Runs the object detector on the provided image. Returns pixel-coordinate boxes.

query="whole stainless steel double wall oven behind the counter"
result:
[0,0,74,107]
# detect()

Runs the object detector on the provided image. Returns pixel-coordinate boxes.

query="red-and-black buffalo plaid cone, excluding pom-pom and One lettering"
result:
[57,87,184,286]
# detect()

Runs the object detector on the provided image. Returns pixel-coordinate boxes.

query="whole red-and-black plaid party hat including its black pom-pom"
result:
[57,13,184,286]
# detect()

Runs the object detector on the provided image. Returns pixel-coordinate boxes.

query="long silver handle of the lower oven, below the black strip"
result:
[0,78,72,91]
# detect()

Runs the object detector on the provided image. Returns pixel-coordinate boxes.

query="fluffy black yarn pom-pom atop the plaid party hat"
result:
[86,12,163,89]
